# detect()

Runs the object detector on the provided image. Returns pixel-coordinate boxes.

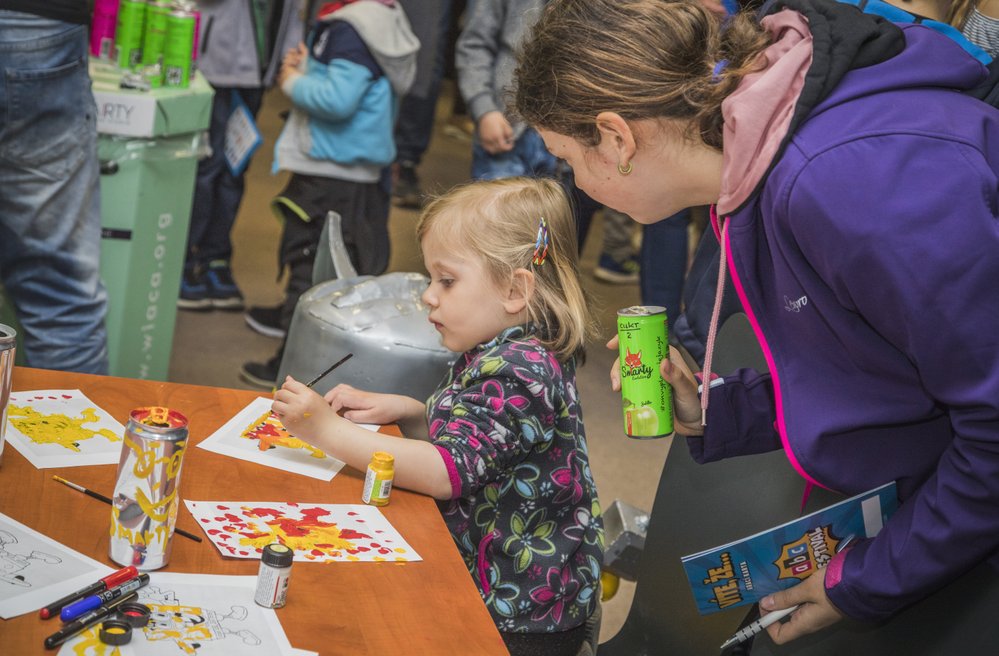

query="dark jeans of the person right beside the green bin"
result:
[185,87,264,268]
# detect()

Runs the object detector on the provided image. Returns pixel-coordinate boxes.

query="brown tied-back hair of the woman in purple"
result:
[514,0,770,149]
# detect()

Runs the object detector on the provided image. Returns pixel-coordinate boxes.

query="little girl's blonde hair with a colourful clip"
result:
[416,178,596,361]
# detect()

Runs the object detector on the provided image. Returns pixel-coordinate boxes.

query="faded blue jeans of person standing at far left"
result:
[0,10,108,373]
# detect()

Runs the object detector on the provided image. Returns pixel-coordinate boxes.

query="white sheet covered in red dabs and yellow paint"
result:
[184,500,423,562]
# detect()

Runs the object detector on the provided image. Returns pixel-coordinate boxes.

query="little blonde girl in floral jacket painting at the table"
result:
[273,178,604,656]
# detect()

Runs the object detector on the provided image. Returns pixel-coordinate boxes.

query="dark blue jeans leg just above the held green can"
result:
[639,210,690,329]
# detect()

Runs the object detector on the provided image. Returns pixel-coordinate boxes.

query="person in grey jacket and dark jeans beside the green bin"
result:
[177,0,303,310]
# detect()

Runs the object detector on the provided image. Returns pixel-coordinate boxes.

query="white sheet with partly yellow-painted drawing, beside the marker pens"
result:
[59,572,300,656]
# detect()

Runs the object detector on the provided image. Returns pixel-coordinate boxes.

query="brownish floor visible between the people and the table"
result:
[170,84,668,641]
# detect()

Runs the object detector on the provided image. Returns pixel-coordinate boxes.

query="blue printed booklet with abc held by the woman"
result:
[681,482,898,615]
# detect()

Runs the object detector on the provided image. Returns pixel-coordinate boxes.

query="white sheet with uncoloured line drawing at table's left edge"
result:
[0,513,114,616]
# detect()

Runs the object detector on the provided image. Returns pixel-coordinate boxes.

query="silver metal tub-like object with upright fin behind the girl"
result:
[277,212,456,401]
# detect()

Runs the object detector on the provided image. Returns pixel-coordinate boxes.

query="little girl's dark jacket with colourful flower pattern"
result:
[427,327,604,633]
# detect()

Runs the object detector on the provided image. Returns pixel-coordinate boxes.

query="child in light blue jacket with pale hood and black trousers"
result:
[240,0,420,388]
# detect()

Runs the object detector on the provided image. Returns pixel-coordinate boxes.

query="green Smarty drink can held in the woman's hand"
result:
[617,305,673,439]
